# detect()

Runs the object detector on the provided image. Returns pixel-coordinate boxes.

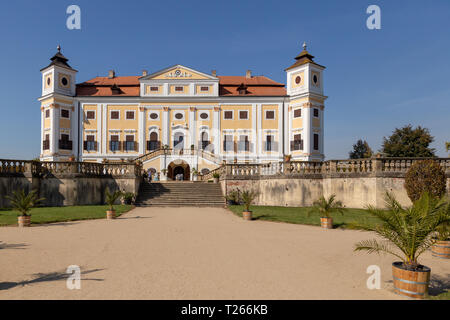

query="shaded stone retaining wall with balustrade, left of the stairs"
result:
[0,160,141,208]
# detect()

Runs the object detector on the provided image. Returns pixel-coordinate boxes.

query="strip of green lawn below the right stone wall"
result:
[228,205,377,228]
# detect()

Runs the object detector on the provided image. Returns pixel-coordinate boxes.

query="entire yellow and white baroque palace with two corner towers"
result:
[39,44,327,180]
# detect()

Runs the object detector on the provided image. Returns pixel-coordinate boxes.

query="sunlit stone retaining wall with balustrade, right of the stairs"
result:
[216,158,450,208]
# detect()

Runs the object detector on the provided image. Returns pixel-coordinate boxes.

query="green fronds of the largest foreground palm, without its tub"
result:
[355,192,450,270]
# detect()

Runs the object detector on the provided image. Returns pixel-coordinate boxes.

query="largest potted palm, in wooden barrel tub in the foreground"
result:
[355,192,450,299]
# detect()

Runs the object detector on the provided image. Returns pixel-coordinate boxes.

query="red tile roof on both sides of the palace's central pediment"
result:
[77,76,286,97]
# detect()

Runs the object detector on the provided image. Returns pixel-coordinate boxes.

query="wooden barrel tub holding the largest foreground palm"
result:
[392,262,431,299]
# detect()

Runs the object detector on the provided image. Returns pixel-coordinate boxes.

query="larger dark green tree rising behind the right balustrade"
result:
[381,124,435,157]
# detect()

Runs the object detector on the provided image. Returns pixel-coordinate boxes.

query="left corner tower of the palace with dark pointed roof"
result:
[38,46,78,161]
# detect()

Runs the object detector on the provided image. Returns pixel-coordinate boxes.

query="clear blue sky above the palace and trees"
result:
[0,0,450,159]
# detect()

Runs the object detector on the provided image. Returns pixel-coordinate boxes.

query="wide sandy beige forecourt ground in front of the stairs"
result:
[0,208,450,299]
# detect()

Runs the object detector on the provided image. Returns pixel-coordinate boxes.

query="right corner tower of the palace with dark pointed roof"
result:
[285,43,327,161]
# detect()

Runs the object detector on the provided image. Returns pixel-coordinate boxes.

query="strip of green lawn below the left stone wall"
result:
[0,205,132,226]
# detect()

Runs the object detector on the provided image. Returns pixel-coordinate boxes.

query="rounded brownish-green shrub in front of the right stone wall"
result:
[404,160,446,202]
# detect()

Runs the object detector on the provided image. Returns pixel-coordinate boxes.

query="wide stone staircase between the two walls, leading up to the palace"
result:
[136,181,225,207]
